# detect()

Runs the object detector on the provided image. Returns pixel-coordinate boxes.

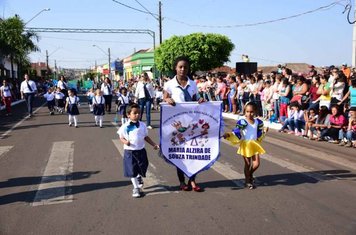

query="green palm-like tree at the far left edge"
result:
[0,16,39,80]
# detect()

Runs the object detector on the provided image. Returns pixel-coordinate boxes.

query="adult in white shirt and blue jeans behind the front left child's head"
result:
[135,72,154,129]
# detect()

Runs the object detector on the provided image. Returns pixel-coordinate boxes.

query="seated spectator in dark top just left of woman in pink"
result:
[309,106,330,141]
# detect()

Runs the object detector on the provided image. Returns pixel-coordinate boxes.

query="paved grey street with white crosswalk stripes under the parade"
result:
[0,96,356,234]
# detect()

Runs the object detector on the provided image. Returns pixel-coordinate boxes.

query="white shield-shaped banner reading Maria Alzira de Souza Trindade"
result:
[160,101,222,177]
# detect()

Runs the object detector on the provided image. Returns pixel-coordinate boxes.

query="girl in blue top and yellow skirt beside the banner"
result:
[224,102,268,189]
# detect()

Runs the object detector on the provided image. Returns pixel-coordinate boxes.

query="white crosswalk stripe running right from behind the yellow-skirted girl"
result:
[222,139,330,181]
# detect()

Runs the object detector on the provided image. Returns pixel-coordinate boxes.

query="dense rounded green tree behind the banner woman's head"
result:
[155,33,235,72]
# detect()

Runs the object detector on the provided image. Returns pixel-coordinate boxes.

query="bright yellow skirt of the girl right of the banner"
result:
[226,134,266,157]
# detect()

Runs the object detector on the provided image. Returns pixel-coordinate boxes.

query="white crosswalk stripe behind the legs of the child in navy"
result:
[112,139,172,196]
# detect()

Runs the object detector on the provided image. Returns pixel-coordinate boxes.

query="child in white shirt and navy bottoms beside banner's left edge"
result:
[117,104,159,198]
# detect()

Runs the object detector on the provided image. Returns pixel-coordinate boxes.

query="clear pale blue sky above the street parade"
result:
[0,0,354,68]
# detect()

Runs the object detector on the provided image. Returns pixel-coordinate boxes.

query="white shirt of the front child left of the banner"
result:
[117,122,148,150]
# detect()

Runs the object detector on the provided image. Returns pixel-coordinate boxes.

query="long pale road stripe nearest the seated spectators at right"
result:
[264,137,356,170]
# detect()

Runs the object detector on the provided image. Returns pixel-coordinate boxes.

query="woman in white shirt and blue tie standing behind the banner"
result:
[163,56,204,192]
